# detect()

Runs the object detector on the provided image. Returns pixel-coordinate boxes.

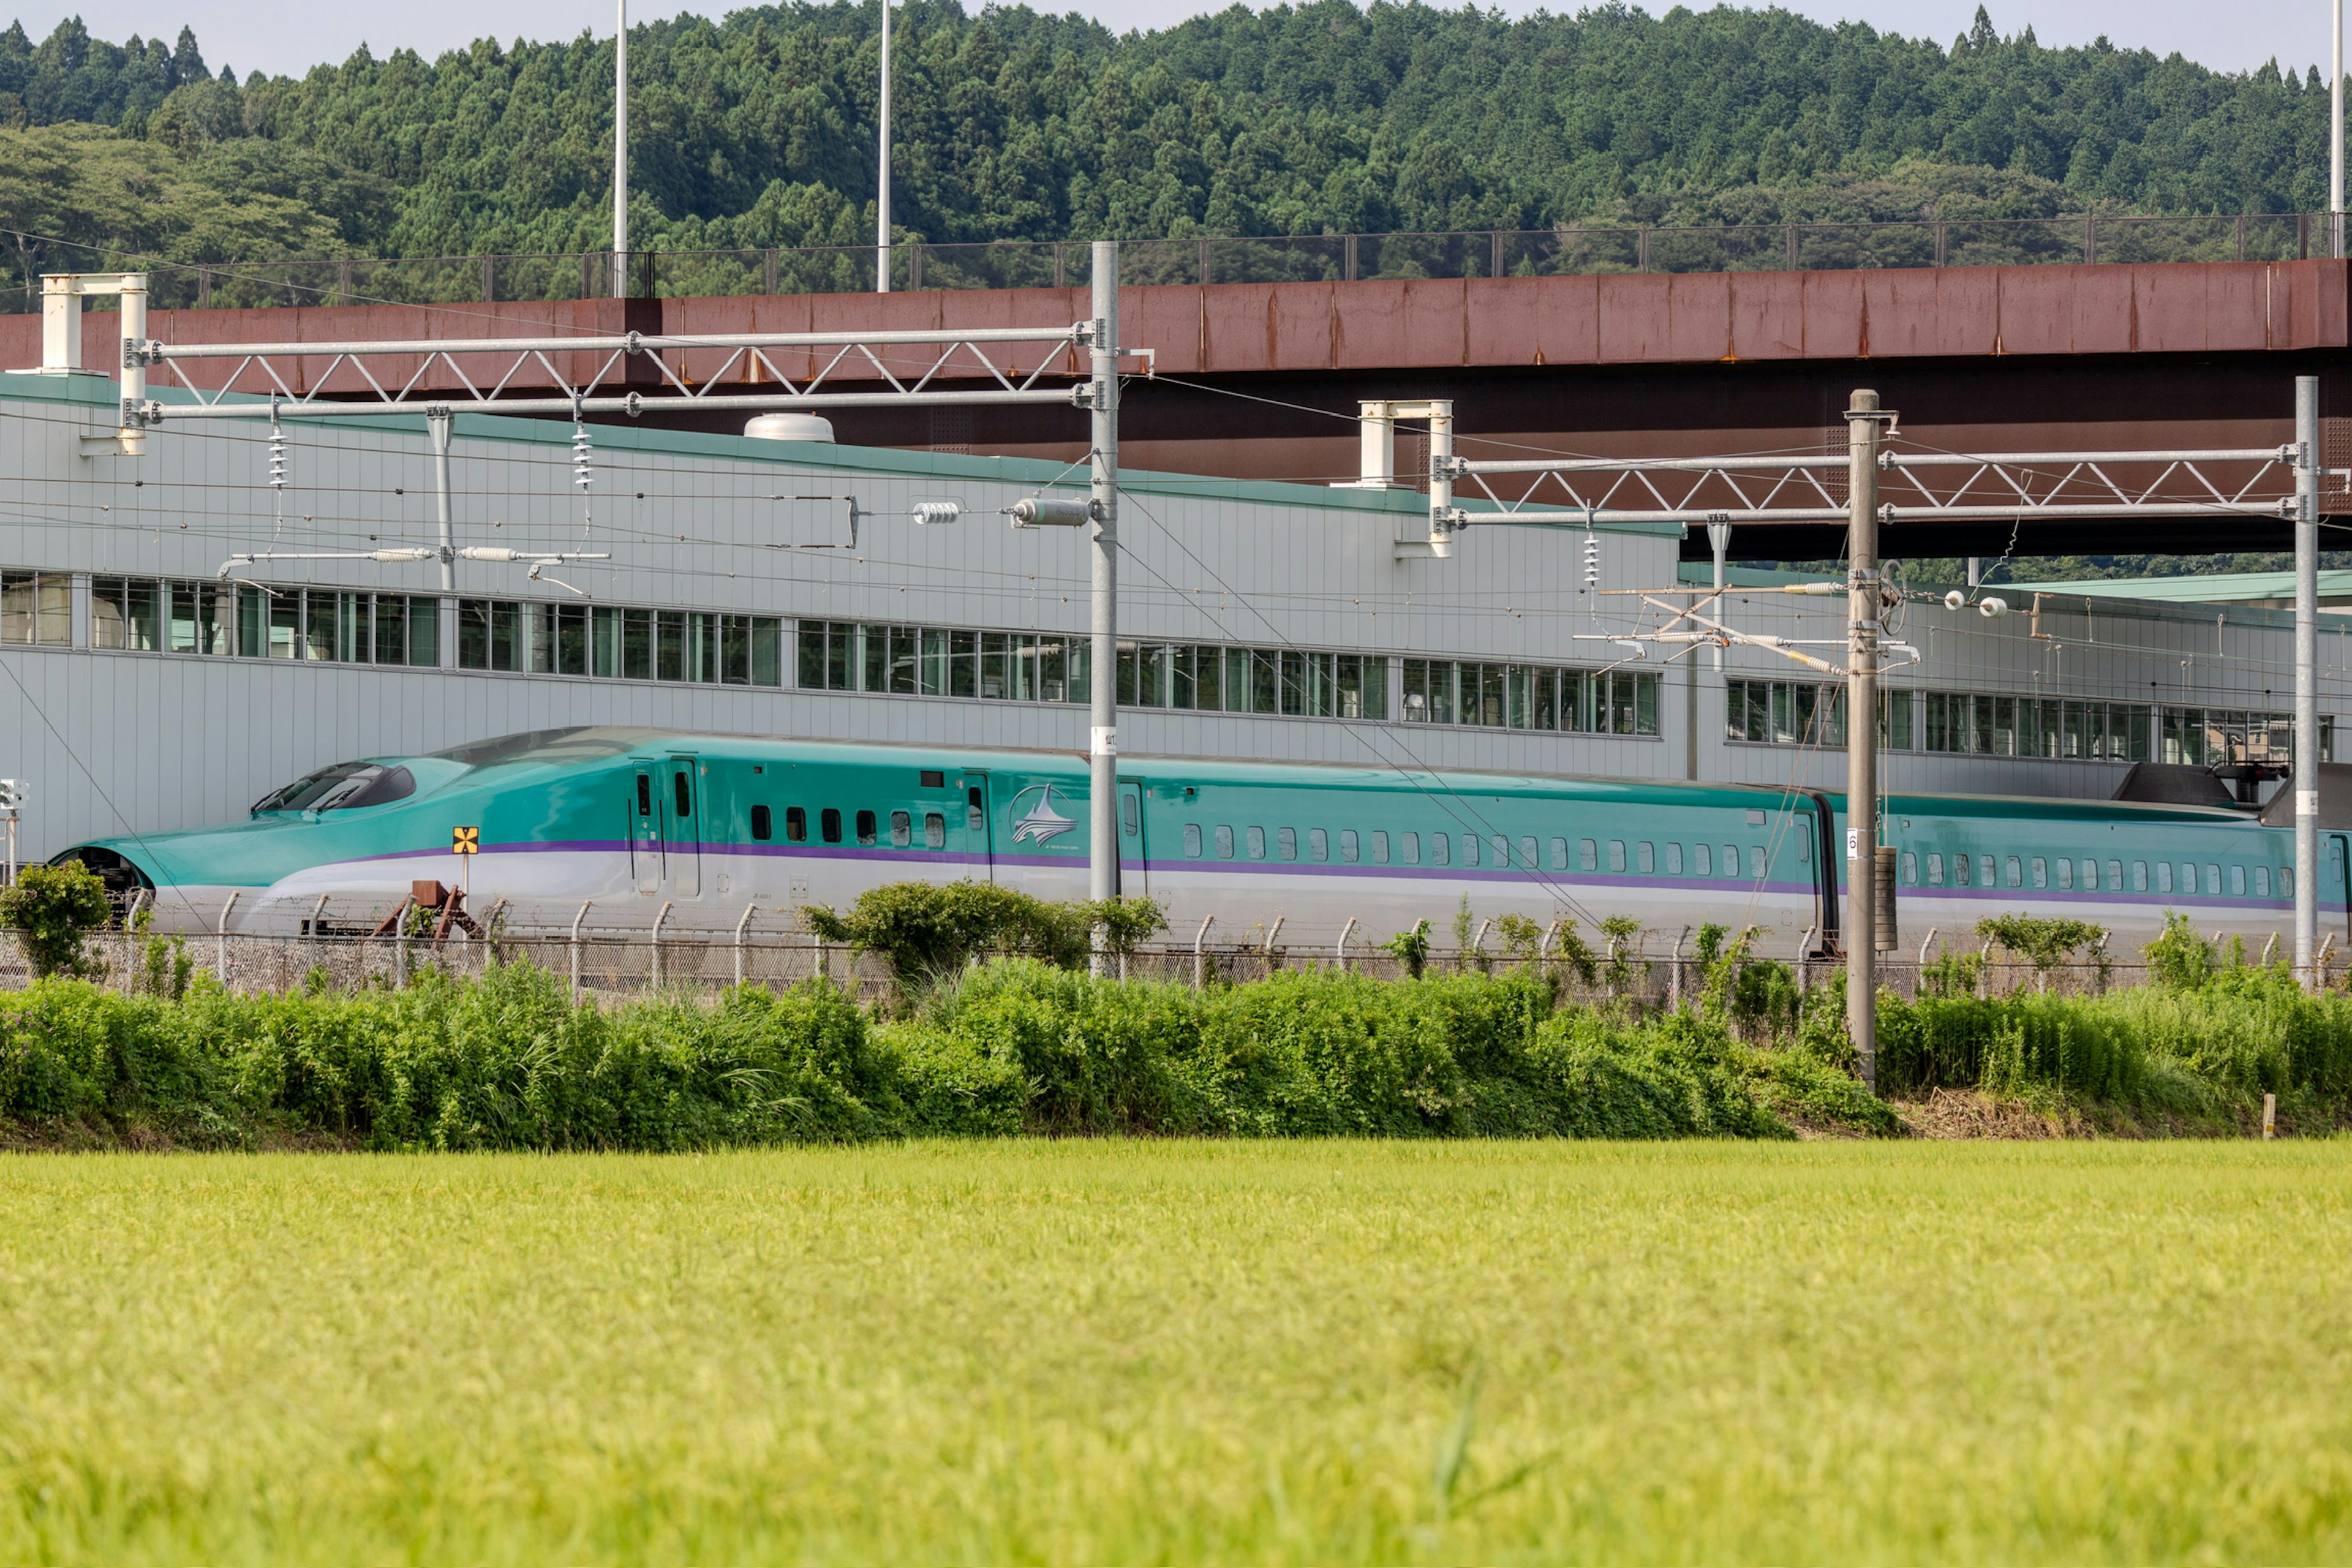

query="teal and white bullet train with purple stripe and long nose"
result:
[59,729,2347,952]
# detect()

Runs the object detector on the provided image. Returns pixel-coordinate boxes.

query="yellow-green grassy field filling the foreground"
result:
[0,1140,2352,1563]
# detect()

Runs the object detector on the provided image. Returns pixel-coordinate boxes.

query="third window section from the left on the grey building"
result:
[456,600,783,687]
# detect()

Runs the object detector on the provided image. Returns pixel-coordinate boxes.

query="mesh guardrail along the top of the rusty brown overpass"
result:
[0,211,2333,312]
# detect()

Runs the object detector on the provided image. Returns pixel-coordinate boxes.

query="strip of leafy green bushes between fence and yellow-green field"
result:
[0,879,2352,1150]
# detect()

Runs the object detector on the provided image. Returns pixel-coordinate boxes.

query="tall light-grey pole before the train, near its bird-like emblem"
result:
[1087,239,1120,971]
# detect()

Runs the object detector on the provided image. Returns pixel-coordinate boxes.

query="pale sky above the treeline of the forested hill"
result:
[0,0,2329,75]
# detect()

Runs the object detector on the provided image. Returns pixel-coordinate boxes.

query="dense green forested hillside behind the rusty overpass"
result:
[0,0,2326,277]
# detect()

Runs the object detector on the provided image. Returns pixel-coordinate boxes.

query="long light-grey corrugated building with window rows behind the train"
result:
[0,374,2352,856]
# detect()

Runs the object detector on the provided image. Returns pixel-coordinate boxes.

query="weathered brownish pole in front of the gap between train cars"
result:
[1846,388,1887,1091]
